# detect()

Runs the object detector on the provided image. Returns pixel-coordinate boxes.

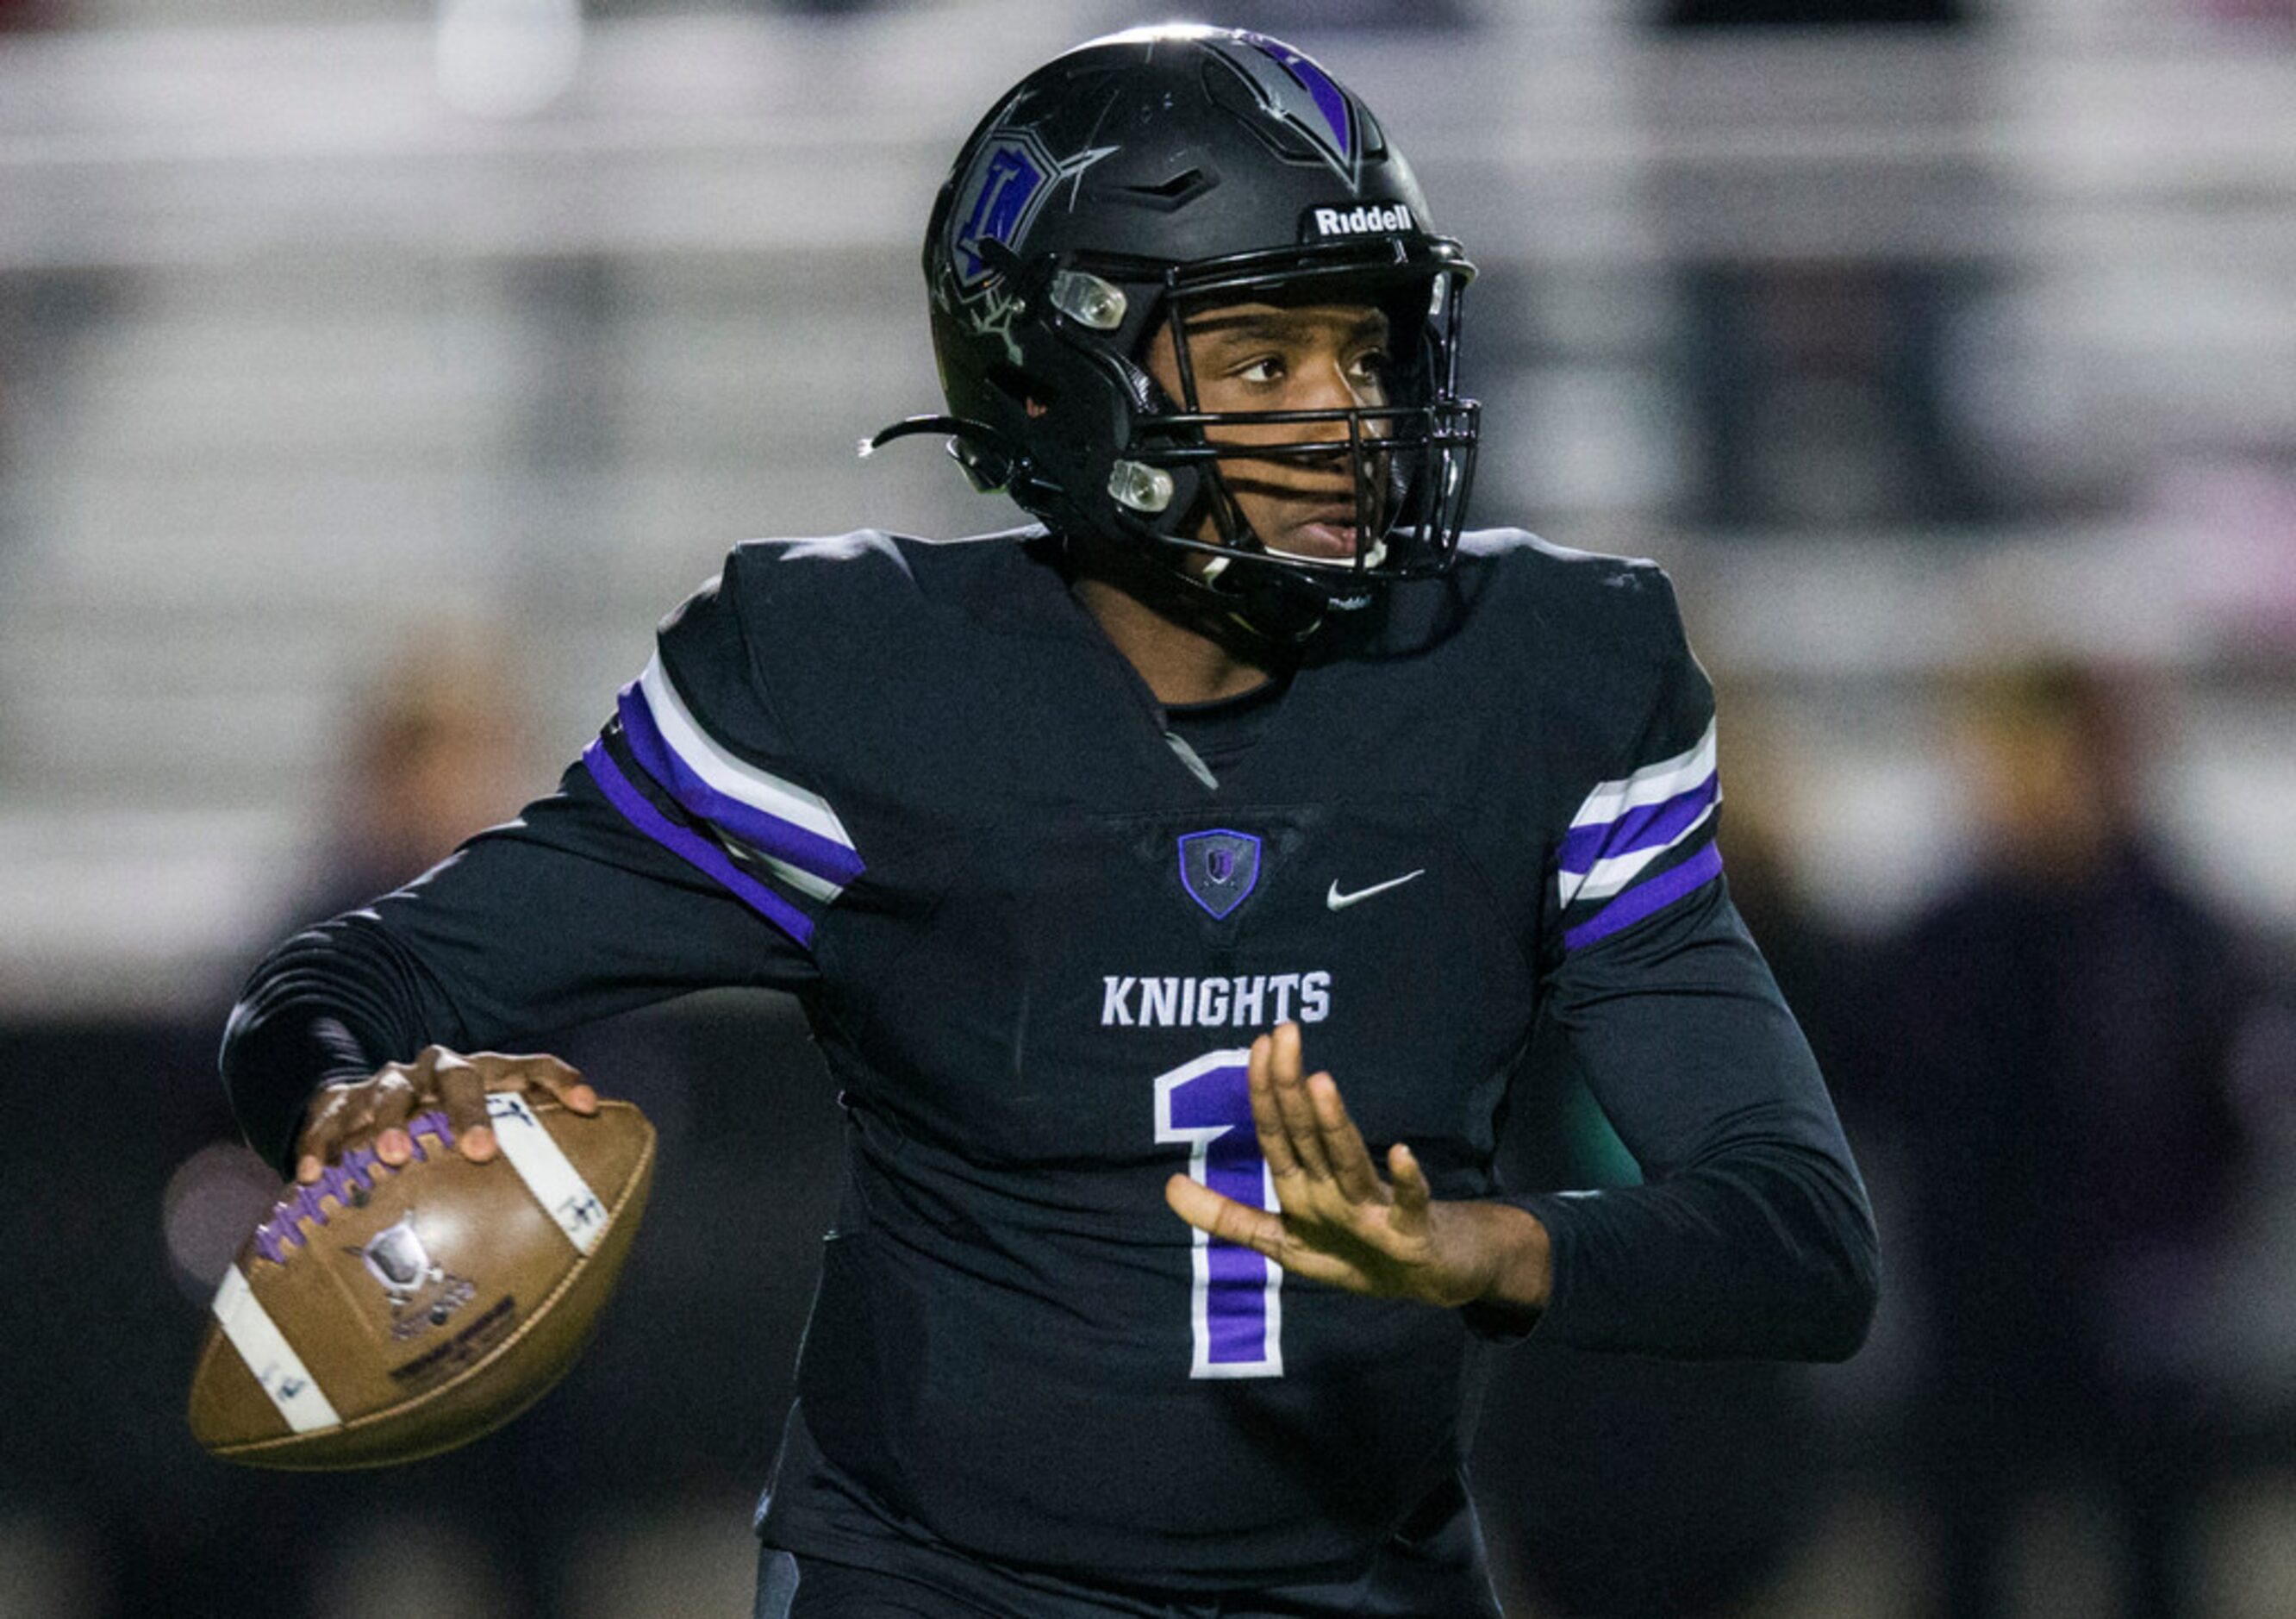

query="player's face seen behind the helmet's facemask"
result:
[1148,303,1389,560]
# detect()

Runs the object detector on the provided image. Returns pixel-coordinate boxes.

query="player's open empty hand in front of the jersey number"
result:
[1164,1024,1548,1309]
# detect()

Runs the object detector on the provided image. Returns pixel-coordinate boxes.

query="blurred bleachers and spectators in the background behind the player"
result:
[0,0,2296,1619]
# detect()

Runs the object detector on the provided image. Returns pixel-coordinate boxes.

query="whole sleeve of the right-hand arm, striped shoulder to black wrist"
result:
[1474,570,1878,1360]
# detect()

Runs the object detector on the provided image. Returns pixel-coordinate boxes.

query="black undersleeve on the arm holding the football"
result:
[221,765,813,1166]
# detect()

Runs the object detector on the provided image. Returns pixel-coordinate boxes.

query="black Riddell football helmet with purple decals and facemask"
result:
[868,25,1481,646]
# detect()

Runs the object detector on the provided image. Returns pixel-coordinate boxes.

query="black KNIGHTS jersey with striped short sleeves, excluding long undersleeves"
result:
[569,533,1719,1587]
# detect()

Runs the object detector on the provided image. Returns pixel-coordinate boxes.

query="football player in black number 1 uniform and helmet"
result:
[222,28,1875,1616]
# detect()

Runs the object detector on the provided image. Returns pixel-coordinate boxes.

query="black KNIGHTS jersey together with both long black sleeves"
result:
[228,533,1871,1589]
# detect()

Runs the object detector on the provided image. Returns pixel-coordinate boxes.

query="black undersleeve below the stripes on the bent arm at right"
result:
[1476,879,1878,1360]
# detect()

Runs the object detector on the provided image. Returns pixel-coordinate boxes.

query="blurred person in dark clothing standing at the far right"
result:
[1874,664,2248,1619]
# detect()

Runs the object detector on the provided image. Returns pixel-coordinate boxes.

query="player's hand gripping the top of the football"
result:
[294,1045,597,1185]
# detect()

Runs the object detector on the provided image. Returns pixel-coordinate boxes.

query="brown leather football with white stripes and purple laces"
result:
[190,1091,654,1467]
